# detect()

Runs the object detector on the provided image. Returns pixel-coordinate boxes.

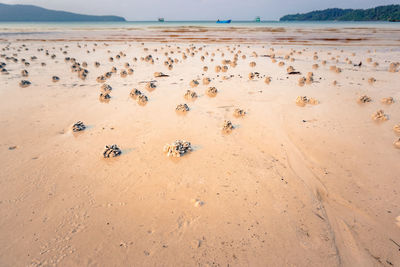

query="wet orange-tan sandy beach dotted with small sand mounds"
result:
[0,24,400,266]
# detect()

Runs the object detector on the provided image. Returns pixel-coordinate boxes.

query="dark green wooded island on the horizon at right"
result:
[280,5,400,22]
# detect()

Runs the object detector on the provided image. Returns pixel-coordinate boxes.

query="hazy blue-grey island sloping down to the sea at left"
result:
[0,4,125,22]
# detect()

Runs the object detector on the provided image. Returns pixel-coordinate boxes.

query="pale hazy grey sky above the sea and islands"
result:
[0,0,400,21]
